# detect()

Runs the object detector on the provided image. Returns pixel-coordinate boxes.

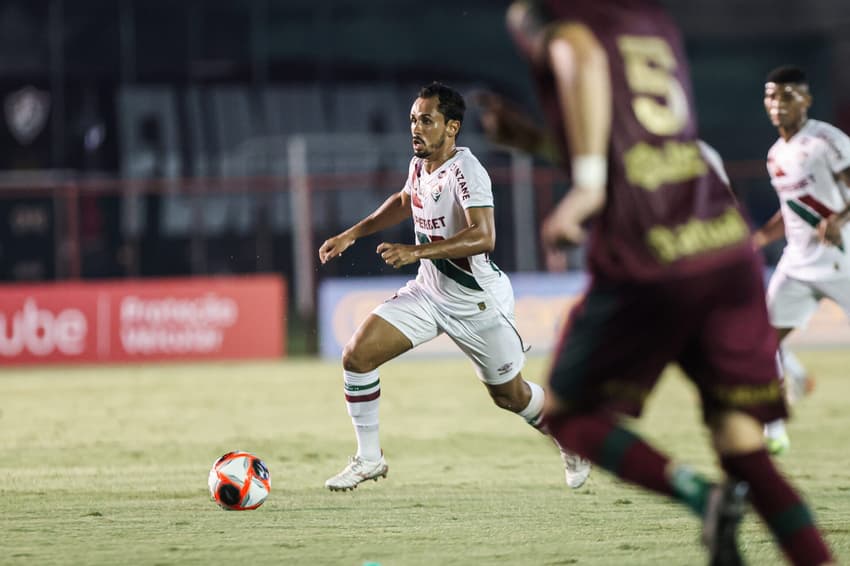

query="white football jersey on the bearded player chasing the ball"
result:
[402,147,513,316]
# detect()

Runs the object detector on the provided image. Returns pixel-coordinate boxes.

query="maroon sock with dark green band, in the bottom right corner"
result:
[720,450,832,566]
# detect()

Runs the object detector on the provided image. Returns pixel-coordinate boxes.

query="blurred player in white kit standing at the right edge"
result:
[753,66,850,454]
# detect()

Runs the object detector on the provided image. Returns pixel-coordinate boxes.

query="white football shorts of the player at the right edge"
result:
[767,271,850,328]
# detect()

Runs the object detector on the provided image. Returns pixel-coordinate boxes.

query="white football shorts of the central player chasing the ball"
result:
[372,279,525,385]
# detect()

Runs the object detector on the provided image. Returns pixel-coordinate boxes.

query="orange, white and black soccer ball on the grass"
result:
[207,450,272,511]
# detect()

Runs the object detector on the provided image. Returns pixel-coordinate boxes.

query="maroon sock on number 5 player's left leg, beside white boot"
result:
[545,413,675,502]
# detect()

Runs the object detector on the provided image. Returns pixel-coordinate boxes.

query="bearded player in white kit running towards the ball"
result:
[319,83,590,491]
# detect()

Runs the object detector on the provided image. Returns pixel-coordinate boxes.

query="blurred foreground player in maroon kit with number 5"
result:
[508,0,832,564]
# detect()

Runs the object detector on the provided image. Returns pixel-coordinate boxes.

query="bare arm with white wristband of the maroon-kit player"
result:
[542,23,612,245]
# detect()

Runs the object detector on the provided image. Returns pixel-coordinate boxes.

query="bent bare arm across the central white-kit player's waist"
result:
[377,207,496,269]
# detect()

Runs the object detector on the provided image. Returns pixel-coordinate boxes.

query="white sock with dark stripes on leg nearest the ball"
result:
[342,370,381,461]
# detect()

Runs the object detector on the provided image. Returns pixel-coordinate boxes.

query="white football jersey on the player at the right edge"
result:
[767,119,850,281]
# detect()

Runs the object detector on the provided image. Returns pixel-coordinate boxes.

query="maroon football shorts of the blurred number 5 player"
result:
[550,260,787,422]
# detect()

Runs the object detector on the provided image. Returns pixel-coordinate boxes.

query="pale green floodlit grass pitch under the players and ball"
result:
[0,351,850,566]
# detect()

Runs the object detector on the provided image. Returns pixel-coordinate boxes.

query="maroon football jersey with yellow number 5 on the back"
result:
[534,0,752,281]
